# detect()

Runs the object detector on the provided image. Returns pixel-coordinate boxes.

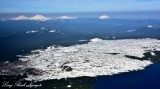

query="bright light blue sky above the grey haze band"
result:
[0,0,160,13]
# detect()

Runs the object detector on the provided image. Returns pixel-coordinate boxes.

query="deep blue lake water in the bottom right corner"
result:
[94,64,160,89]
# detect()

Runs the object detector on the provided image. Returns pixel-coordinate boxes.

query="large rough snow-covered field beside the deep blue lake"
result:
[16,38,160,81]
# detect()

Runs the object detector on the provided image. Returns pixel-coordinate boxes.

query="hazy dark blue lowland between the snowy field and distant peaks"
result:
[0,18,160,61]
